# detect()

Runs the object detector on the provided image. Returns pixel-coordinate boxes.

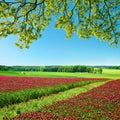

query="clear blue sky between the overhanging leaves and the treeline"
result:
[0,22,120,66]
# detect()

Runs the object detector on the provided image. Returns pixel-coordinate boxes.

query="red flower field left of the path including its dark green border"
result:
[0,76,107,108]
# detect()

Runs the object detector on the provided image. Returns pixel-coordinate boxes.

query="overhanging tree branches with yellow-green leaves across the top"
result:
[0,0,120,48]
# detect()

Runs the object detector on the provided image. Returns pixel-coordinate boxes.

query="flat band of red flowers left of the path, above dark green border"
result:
[0,76,105,92]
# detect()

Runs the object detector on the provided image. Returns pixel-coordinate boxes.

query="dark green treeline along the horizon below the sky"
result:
[0,65,120,73]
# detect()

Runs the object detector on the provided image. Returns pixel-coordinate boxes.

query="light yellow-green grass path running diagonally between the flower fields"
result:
[0,81,107,120]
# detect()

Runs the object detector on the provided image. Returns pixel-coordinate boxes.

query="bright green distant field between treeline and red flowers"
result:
[0,69,120,79]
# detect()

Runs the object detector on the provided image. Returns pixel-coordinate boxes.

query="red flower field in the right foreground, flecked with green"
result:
[12,80,120,120]
